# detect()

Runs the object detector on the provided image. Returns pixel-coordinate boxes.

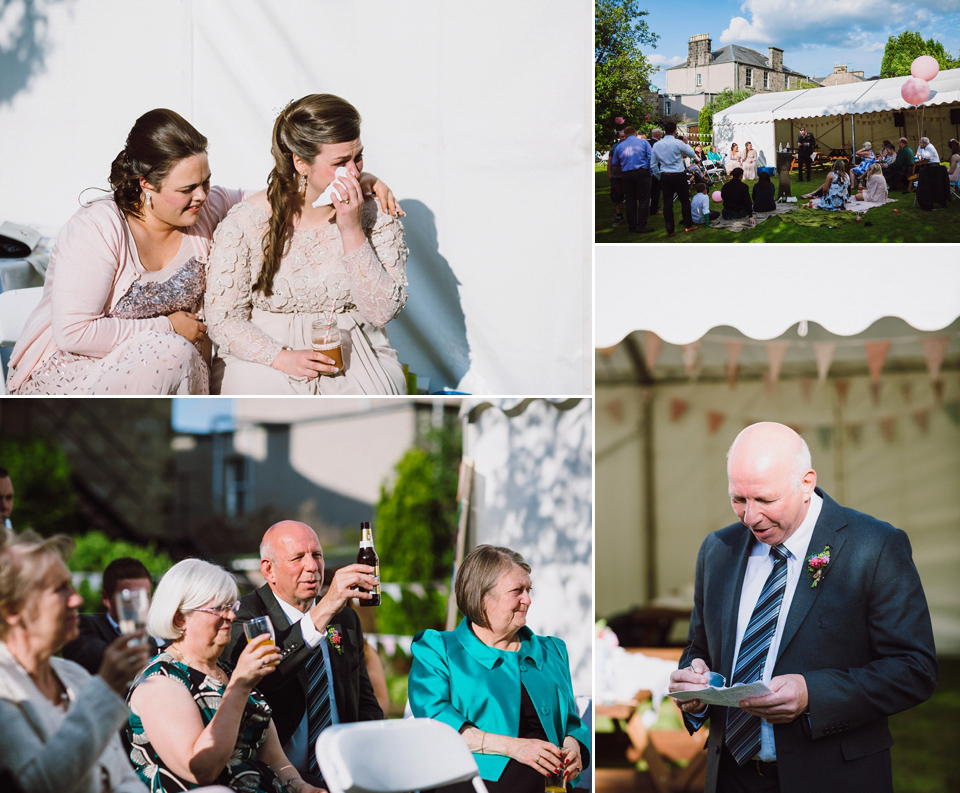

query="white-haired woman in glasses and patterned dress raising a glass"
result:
[127,559,320,793]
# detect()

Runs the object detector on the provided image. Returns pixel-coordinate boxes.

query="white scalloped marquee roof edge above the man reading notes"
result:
[595,258,960,348]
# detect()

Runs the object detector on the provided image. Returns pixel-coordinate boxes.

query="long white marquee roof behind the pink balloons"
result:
[715,69,960,124]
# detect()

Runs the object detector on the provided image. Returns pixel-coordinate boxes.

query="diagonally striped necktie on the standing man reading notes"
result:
[726,545,787,765]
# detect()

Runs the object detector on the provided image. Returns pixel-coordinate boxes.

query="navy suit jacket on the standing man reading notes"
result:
[680,488,937,793]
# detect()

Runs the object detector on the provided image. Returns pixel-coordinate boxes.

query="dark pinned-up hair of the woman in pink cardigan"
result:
[110,108,207,220]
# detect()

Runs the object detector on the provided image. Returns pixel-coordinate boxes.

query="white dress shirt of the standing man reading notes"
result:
[733,493,823,763]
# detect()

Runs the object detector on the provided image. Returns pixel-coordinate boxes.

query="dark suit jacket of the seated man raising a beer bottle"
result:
[224,584,383,744]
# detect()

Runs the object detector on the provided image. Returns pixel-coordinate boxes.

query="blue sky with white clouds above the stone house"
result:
[638,0,960,90]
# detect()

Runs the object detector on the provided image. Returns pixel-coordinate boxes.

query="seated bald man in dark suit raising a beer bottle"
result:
[224,520,384,786]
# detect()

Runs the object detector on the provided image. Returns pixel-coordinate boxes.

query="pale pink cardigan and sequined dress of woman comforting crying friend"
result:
[7,187,242,395]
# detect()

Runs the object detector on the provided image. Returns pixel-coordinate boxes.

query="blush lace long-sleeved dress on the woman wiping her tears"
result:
[205,200,407,395]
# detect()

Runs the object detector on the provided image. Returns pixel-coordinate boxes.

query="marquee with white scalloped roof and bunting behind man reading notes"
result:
[596,255,960,655]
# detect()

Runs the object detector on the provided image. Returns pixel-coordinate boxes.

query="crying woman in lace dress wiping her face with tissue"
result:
[205,94,407,394]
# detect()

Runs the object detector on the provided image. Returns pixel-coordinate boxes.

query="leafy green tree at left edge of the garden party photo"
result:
[594,0,659,149]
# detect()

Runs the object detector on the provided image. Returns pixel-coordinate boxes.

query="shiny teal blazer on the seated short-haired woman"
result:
[407,619,590,784]
